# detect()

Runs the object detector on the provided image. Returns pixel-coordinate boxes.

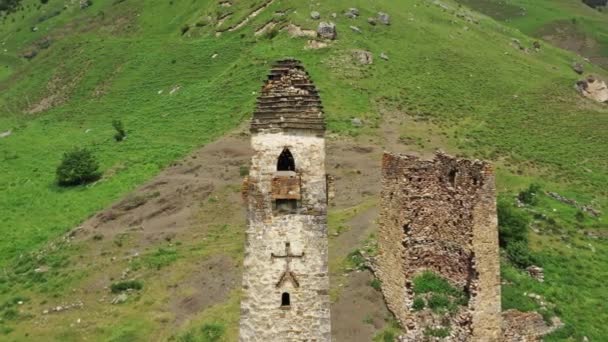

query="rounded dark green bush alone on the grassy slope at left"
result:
[57,148,101,186]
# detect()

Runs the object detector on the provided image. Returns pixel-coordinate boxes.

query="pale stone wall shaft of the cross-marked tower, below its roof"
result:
[240,131,331,342]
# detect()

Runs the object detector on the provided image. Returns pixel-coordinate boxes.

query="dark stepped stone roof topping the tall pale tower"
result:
[251,59,325,133]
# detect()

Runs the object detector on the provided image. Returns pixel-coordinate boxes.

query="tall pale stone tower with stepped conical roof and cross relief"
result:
[240,59,331,342]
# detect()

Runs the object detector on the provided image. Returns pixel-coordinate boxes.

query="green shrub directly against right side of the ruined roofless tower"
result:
[497,200,530,247]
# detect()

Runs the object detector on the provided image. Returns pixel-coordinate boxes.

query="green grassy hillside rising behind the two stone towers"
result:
[0,0,608,341]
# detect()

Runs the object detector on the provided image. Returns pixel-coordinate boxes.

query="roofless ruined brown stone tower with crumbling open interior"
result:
[377,153,500,341]
